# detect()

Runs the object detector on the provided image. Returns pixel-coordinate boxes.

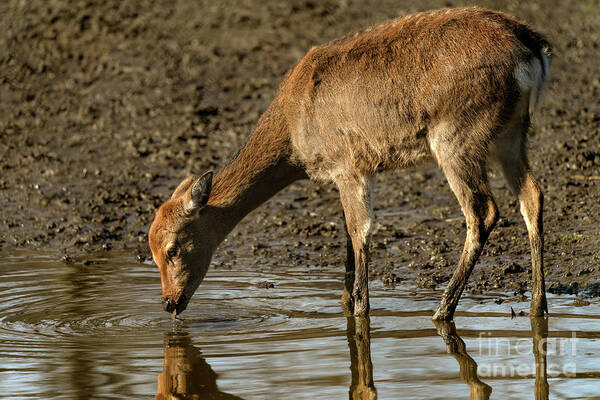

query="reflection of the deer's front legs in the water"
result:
[346,316,377,400]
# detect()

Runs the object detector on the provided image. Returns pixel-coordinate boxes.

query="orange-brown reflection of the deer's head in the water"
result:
[156,332,241,400]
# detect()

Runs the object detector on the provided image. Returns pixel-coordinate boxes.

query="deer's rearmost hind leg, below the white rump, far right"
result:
[496,115,548,317]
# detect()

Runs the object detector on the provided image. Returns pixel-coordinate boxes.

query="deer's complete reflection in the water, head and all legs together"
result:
[156,317,549,400]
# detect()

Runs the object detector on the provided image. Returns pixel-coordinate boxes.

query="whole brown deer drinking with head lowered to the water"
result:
[149,8,550,320]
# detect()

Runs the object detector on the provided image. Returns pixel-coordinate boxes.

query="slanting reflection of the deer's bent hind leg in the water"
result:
[434,321,492,400]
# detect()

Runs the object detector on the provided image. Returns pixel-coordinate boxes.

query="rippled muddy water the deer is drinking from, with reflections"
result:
[0,253,600,399]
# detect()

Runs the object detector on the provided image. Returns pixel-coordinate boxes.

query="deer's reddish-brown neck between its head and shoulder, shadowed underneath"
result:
[208,104,306,241]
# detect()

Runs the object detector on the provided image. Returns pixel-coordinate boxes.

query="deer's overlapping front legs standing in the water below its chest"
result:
[336,176,372,316]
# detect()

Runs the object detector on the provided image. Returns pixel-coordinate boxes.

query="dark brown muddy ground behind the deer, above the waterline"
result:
[0,0,600,296]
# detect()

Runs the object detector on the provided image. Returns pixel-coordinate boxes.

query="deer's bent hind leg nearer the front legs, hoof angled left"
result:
[433,148,498,321]
